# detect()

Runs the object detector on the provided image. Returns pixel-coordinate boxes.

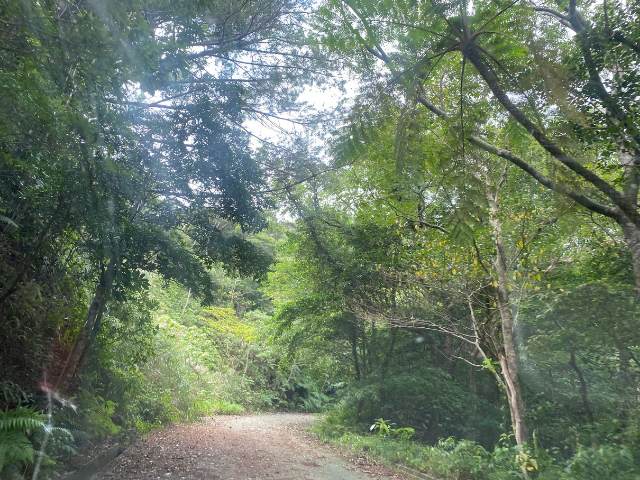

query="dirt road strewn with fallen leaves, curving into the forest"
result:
[92,414,408,480]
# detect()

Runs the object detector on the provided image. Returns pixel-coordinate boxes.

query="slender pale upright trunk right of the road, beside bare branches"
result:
[487,194,530,445]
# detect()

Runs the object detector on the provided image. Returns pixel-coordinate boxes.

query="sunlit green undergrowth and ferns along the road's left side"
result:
[0,279,326,480]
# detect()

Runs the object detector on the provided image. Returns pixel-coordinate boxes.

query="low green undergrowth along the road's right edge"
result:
[311,410,640,480]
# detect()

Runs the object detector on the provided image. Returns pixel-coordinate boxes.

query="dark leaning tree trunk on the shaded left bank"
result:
[54,258,116,396]
